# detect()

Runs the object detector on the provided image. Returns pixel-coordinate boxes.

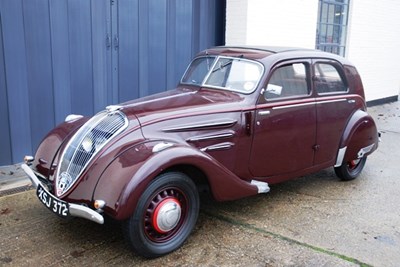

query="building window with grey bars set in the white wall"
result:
[316,0,350,56]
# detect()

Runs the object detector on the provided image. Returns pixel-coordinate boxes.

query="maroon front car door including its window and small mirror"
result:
[249,60,316,177]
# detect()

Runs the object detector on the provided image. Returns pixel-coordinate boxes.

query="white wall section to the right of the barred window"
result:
[346,0,400,100]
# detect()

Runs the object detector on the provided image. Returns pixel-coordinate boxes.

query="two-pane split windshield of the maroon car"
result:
[181,56,263,93]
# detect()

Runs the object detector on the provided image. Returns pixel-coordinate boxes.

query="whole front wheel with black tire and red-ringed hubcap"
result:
[124,172,200,258]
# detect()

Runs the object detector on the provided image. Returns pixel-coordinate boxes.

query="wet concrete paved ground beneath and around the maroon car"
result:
[0,102,400,266]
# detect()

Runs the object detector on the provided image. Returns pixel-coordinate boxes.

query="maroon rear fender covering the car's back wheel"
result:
[336,110,379,166]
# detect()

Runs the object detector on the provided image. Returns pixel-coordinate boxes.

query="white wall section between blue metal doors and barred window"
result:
[226,0,318,48]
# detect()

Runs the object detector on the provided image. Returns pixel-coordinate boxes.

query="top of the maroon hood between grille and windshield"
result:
[117,87,248,124]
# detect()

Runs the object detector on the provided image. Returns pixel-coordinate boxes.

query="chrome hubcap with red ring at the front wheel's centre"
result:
[153,198,182,233]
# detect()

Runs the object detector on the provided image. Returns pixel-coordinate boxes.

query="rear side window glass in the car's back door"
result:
[314,63,347,94]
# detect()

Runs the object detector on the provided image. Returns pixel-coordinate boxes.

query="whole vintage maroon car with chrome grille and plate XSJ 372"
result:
[23,47,379,257]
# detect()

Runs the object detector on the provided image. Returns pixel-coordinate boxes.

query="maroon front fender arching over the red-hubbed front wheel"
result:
[94,141,258,220]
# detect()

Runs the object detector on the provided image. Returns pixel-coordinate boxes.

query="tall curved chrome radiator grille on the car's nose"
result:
[56,111,128,196]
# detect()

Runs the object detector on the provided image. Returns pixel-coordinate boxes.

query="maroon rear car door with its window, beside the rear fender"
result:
[312,59,356,165]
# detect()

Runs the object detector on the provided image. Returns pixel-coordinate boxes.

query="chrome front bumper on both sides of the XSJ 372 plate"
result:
[21,164,104,224]
